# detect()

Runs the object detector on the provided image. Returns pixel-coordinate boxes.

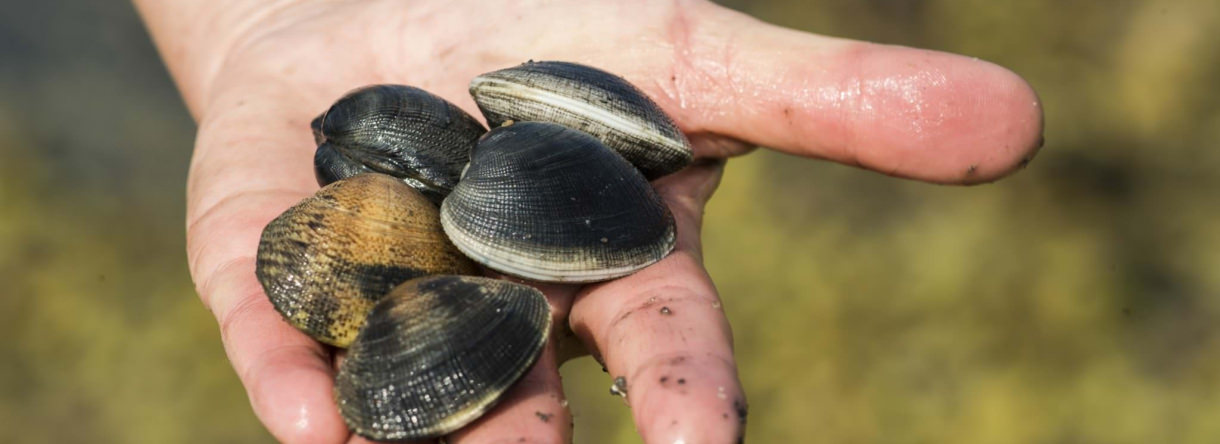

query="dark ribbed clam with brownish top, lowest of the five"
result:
[334,276,550,440]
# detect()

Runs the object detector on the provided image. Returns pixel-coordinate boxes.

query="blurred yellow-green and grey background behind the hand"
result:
[0,0,1220,443]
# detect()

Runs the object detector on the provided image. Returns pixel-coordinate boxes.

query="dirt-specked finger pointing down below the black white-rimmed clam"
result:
[571,163,745,443]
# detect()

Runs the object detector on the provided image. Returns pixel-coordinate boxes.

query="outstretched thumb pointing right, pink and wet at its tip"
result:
[649,4,1042,183]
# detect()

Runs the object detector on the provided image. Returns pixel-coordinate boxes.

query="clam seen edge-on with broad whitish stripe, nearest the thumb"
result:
[470,61,693,179]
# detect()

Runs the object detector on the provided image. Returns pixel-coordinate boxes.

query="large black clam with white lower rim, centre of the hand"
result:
[440,122,675,282]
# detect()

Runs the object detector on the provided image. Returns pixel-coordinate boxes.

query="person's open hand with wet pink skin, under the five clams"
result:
[137,0,1042,443]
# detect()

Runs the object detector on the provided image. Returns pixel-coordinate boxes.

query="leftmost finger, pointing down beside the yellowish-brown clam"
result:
[203,259,348,443]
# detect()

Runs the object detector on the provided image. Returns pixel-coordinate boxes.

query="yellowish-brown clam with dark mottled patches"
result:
[255,173,477,346]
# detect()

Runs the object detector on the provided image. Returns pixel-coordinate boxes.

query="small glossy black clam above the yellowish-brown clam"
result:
[311,85,487,204]
